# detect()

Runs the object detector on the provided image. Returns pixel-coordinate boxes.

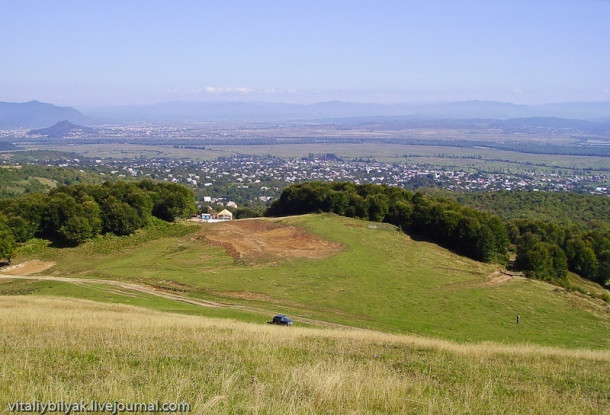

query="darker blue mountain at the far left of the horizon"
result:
[0,101,88,129]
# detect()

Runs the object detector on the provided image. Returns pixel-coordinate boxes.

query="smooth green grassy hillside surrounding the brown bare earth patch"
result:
[5,215,610,348]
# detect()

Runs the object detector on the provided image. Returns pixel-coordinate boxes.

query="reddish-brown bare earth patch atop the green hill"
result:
[203,219,343,260]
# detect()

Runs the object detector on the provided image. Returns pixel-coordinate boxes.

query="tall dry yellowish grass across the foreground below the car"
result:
[0,297,610,414]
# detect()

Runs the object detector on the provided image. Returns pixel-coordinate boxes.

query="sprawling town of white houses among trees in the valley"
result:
[96,156,610,197]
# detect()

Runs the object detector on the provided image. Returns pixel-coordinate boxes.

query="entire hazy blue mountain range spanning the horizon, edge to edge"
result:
[0,101,610,129]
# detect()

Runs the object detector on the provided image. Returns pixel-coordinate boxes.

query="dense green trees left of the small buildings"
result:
[0,180,195,262]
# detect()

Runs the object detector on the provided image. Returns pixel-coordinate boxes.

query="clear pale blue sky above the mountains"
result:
[0,0,610,106]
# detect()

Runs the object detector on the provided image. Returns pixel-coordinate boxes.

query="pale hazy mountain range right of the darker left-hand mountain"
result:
[82,101,610,122]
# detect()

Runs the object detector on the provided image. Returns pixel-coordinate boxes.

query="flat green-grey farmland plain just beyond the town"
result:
[15,143,610,174]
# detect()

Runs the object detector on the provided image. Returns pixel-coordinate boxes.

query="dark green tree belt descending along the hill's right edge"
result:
[266,182,610,285]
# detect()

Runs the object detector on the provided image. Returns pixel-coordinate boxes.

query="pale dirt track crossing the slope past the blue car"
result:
[0,273,357,330]
